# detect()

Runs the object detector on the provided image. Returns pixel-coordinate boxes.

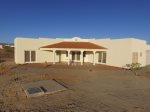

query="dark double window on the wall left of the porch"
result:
[24,51,36,62]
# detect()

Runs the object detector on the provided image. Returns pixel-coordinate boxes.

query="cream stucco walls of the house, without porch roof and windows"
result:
[15,37,150,67]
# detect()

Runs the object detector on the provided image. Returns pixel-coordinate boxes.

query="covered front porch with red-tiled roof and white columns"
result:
[40,42,107,65]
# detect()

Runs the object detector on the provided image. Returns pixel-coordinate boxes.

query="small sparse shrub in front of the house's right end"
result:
[126,63,141,75]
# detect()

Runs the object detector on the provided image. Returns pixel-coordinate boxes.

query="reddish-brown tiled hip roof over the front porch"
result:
[41,42,106,49]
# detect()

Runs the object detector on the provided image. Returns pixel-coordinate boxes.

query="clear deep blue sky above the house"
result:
[0,0,150,42]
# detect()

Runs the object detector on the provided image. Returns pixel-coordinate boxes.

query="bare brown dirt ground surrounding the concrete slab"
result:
[0,63,150,112]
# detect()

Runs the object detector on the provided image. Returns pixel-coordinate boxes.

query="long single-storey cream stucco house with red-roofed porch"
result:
[14,37,150,67]
